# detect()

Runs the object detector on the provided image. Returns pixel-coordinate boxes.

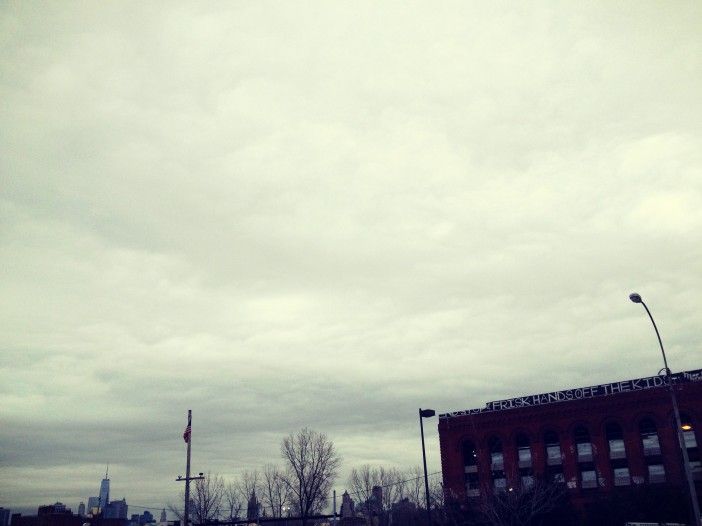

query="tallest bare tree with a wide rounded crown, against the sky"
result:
[280,428,341,526]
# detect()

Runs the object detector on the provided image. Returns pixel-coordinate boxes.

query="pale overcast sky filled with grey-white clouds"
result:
[0,0,702,512]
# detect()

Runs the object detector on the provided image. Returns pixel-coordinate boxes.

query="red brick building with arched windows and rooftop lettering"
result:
[439,370,702,507]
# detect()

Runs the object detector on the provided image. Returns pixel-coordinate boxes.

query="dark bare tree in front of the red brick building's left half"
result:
[481,482,564,526]
